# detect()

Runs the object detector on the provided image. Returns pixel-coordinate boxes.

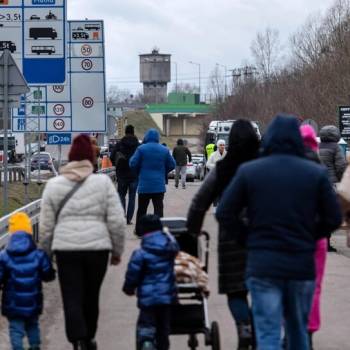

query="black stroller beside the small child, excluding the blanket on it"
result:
[162,218,220,350]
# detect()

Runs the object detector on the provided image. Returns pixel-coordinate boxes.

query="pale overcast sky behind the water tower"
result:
[68,0,334,93]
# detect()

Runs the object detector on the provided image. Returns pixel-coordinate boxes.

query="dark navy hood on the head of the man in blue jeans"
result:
[262,115,305,157]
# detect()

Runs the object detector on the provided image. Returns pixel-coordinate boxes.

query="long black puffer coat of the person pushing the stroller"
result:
[187,169,246,294]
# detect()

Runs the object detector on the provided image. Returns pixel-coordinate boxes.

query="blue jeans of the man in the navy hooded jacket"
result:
[247,277,315,350]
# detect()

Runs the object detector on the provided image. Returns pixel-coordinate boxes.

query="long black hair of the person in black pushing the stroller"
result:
[216,119,260,194]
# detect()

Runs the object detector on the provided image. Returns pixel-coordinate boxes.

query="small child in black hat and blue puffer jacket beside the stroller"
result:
[123,215,179,350]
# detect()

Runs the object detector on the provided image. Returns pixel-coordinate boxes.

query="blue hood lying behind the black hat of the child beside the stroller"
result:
[141,231,179,256]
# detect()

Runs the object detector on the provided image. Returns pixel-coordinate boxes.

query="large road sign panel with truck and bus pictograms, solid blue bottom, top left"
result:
[0,0,67,85]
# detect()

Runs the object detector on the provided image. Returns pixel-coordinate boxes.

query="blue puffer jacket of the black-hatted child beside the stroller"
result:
[123,231,179,308]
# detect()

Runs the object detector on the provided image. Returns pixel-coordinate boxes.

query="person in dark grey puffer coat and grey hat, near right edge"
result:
[320,125,346,183]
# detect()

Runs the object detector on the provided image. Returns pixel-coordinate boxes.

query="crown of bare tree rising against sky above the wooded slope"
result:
[251,28,282,79]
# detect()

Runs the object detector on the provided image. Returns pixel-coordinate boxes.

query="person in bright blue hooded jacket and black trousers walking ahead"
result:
[129,129,176,232]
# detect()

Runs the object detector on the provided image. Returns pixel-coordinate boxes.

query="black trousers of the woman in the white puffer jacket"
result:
[56,251,109,343]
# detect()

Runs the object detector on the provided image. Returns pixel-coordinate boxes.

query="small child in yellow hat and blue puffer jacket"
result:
[0,212,55,350]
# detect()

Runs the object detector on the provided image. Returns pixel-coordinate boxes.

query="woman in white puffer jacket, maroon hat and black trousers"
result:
[39,135,126,350]
